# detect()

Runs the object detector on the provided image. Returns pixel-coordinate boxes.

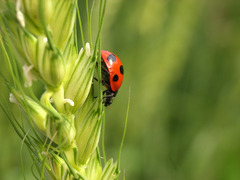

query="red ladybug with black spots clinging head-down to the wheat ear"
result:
[101,50,124,107]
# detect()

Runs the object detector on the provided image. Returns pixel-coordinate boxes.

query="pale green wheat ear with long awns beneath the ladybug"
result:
[0,0,128,180]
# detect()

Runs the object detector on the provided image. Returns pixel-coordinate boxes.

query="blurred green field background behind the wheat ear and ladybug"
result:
[0,0,240,180]
